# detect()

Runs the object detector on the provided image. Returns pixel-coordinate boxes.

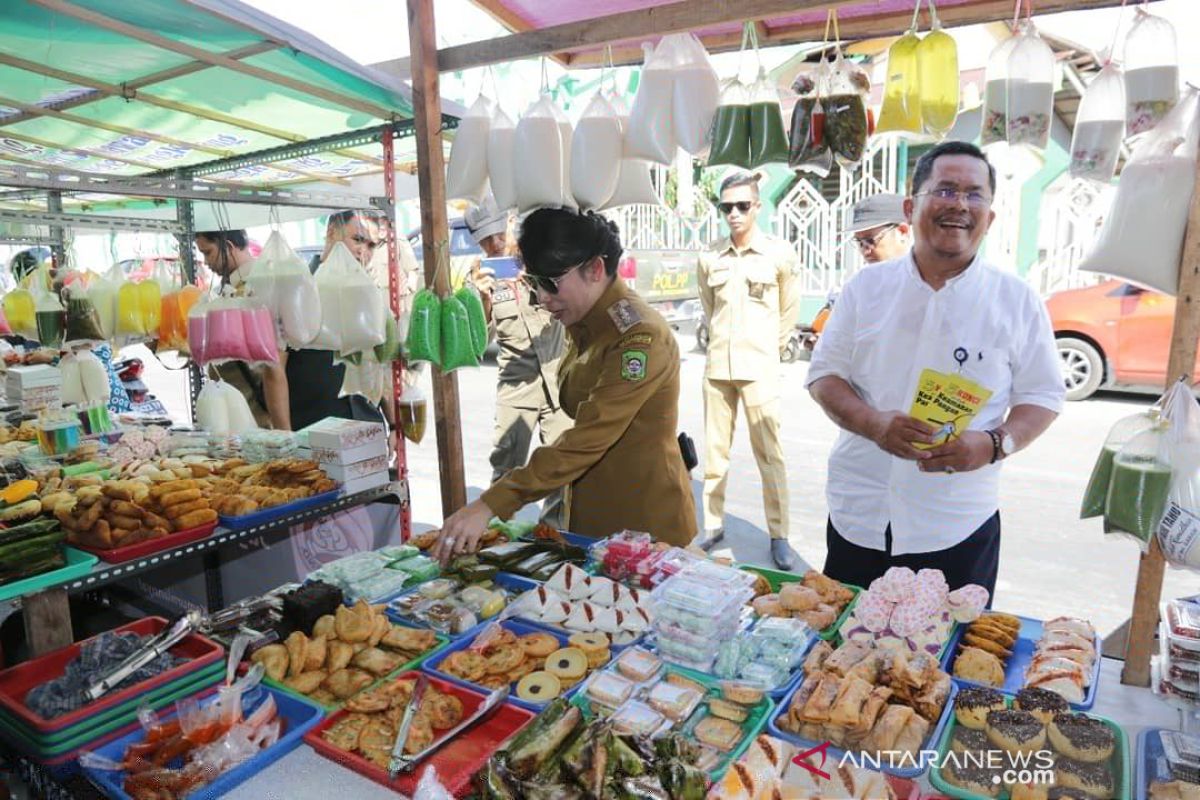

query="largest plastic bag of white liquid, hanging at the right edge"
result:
[1079,88,1200,295]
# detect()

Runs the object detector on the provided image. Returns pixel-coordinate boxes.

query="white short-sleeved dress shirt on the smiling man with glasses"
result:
[808,251,1066,555]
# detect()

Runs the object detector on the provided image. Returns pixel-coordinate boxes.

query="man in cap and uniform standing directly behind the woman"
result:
[464,197,571,525]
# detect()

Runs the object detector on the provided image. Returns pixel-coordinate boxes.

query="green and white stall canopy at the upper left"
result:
[0,0,461,222]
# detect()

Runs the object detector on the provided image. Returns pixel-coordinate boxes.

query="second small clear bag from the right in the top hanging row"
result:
[1068,62,1126,184]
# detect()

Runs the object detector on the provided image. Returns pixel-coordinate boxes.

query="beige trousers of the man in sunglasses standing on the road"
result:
[704,378,787,540]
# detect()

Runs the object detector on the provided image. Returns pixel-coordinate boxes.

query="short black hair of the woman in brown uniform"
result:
[517,209,624,277]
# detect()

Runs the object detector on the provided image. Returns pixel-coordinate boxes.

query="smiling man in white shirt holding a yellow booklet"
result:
[808,142,1064,591]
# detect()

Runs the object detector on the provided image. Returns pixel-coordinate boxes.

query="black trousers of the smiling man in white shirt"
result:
[823,511,1000,599]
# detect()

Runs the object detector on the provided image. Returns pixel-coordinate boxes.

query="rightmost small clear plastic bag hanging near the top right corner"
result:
[1124,7,1180,136]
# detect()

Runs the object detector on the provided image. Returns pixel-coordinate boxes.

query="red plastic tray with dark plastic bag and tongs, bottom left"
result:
[0,616,224,733]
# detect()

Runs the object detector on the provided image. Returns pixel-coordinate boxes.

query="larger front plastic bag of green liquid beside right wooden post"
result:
[1104,412,1171,552]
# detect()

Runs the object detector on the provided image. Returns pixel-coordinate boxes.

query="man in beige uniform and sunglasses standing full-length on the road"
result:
[696,173,800,570]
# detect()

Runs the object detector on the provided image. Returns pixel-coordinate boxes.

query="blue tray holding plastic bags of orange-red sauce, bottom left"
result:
[84,688,323,800]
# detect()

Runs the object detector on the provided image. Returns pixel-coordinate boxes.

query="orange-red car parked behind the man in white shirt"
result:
[1046,281,1200,401]
